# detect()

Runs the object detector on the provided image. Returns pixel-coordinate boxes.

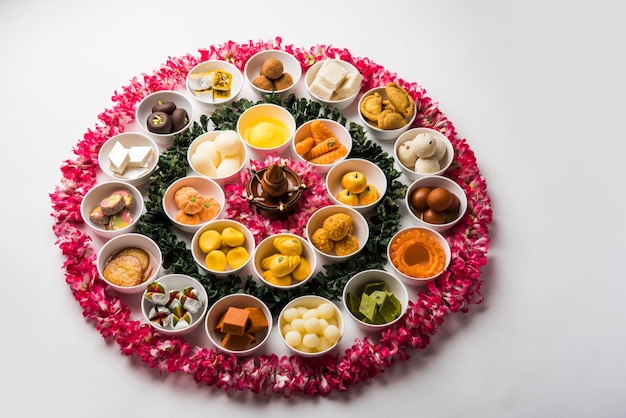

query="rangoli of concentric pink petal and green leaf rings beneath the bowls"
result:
[50,38,492,396]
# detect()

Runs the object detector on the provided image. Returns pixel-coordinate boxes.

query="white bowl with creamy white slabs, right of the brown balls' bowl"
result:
[305,58,363,110]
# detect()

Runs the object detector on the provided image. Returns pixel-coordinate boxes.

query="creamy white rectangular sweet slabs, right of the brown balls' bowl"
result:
[309,59,363,101]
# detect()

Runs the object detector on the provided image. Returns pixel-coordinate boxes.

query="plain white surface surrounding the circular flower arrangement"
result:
[0,0,626,417]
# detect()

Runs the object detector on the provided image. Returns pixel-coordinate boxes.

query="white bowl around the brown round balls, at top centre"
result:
[243,49,302,99]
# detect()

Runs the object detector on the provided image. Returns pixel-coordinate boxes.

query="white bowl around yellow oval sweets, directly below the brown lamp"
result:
[252,233,317,290]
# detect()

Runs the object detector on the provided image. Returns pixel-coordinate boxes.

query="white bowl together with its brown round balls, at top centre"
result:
[243,49,302,98]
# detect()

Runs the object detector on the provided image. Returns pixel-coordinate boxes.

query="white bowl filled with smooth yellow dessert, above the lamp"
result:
[237,103,296,160]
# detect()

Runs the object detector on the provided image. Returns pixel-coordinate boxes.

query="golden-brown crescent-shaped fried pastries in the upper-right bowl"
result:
[359,82,415,130]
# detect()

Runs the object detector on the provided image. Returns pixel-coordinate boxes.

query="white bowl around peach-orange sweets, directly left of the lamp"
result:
[163,176,226,234]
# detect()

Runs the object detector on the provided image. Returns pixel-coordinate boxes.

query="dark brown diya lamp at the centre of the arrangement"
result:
[246,163,306,220]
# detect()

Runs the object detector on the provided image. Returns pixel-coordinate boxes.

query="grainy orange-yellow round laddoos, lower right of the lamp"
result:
[311,212,359,256]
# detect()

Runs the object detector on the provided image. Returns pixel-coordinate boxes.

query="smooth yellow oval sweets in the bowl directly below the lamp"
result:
[261,235,312,287]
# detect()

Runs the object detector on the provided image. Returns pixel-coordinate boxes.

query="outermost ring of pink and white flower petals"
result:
[50,38,492,396]
